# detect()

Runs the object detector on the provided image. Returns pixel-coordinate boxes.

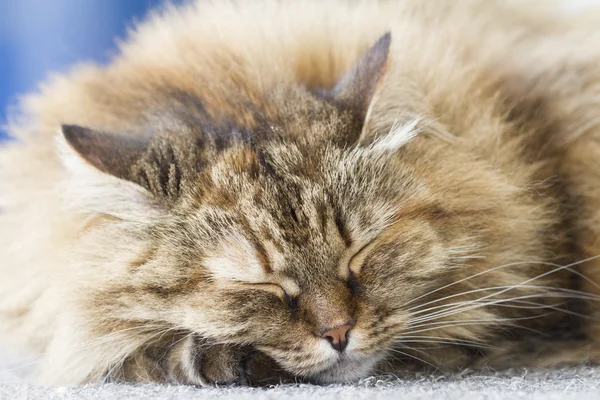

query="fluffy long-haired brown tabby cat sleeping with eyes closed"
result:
[0,0,600,385]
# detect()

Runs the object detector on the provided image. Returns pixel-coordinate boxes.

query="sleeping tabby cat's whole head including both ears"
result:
[56,35,548,382]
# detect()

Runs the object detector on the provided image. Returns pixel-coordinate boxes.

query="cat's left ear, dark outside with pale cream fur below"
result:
[57,125,161,221]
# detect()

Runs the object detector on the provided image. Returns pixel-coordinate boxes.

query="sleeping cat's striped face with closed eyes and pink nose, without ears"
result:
[145,136,451,381]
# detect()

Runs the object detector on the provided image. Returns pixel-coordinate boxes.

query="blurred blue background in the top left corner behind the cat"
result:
[0,0,181,139]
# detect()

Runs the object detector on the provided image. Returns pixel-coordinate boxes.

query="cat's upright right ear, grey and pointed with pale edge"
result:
[325,32,392,139]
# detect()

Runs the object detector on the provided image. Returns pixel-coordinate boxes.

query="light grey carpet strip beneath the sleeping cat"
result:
[0,366,600,400]
